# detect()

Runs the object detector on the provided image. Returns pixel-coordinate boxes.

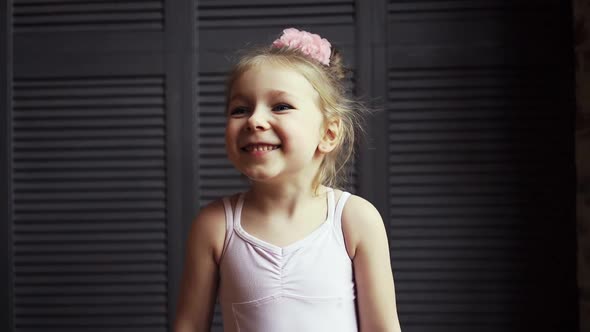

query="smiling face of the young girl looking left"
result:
[225,64,323,182]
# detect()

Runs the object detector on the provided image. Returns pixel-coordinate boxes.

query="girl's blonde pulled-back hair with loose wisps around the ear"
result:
[225,42,369,192]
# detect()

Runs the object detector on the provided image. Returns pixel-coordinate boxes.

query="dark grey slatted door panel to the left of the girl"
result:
[1,0,195,332]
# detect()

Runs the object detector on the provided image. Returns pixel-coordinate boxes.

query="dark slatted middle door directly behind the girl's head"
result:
[198,0,357,331]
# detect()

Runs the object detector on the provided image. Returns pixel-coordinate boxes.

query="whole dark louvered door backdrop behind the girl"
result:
[0,0,578,332]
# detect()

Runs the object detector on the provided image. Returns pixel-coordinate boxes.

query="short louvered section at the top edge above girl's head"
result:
[198,0,354,29]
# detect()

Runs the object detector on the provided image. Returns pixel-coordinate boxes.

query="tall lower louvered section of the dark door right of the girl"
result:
[388,67,553,331]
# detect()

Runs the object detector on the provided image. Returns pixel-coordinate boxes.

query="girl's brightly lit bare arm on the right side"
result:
[342,195,401,332]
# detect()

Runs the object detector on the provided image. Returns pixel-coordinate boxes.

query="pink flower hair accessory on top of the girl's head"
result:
[272,28,332,66]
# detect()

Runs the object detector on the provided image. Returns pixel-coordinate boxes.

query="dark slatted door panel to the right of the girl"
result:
[380,0,577,332]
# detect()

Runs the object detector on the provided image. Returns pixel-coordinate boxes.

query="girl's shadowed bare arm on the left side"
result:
[174,201,225,332]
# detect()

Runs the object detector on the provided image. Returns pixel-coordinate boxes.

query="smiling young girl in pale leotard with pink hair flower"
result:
[175,28,401,332]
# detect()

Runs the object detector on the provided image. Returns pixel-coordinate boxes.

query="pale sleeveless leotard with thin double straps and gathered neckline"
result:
[219,188,358,332]
